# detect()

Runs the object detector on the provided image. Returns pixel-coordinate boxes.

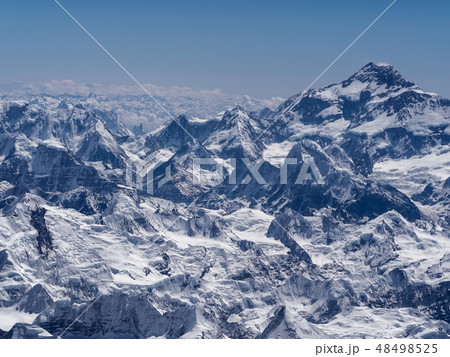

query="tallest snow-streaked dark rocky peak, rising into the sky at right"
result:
[271,63,450,177]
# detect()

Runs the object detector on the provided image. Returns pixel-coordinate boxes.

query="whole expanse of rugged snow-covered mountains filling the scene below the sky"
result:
[0,63,450,338]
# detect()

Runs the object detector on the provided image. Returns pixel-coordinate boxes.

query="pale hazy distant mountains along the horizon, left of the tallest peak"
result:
[0,80,284,134]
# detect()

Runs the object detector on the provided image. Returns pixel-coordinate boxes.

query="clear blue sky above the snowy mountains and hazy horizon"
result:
[0,0,450,97]
